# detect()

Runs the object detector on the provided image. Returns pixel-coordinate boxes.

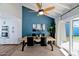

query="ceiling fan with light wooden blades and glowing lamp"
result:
[36,3,55,15]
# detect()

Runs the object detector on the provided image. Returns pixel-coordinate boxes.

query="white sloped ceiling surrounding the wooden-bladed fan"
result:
[22,3,79,18]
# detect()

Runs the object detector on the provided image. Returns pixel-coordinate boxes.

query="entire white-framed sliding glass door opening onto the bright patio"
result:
[61,19,79,56]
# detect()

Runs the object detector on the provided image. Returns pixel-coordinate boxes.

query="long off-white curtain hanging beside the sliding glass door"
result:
[56,17,66,46]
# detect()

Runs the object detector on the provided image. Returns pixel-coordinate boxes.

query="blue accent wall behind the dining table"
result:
[22,7,54,37]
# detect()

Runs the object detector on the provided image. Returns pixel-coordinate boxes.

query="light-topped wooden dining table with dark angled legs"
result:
[22,36,53,51]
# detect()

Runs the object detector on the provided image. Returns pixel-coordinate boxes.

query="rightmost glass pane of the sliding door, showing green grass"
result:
[72,19,79,55]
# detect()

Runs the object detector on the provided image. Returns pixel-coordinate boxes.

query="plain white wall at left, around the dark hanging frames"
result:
[0,3,22,44]
